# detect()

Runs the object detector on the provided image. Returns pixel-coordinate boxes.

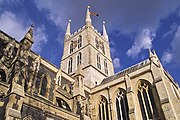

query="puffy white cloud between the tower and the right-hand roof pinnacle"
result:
[126,29,155,57]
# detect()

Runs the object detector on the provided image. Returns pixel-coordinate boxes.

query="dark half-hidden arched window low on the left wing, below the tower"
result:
[56,98,71,111]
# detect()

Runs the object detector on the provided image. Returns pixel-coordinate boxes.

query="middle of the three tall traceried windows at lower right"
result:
[116,90,129,120]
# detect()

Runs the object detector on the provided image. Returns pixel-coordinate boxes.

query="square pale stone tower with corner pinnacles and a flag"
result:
[61,6,114,87]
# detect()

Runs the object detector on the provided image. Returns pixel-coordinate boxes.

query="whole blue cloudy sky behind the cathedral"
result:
[0,0,180,83]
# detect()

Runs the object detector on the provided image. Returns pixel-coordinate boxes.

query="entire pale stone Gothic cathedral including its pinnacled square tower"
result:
[0,7,180,120]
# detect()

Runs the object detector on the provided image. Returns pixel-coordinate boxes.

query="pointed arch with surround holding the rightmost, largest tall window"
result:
[136,79,160,120]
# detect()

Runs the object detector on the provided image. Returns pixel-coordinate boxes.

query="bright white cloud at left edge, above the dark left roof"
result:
[0,11,28,40]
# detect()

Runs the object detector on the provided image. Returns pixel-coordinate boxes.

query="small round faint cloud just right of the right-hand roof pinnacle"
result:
[161,51,172,64]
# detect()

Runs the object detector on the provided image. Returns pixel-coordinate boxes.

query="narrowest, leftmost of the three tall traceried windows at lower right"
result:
[99,96,109,120]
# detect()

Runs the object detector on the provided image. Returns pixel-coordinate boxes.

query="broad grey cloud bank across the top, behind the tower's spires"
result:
[34,0,180,32]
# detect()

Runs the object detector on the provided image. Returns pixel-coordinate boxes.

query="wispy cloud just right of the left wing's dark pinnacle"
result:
[32,26,48,53]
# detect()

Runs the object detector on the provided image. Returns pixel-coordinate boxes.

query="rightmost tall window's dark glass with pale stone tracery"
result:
[138,82,159,120]
